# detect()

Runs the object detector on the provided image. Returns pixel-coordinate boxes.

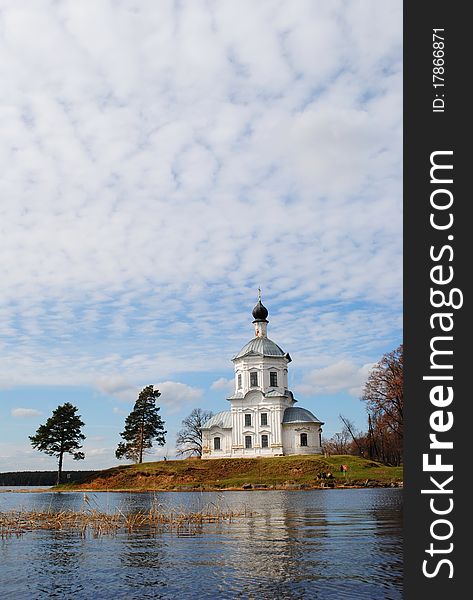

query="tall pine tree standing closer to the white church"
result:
[115,385,167,463]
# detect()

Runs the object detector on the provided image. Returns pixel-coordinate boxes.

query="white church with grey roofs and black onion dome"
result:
[202,296,323,459]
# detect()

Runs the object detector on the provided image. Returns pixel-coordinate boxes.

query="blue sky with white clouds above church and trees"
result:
[0,0,402,471]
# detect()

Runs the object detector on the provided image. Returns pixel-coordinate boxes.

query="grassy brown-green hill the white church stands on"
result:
[56,456,402,491]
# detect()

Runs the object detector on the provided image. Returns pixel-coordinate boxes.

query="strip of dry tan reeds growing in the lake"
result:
[0,499,252,539]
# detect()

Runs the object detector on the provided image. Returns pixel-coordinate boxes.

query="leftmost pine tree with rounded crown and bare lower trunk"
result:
[29,402,85,485]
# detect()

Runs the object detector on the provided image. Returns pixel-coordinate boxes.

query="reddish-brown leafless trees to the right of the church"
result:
[323,344,404,466]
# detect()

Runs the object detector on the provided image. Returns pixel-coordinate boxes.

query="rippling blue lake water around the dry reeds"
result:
[0,489,402,600]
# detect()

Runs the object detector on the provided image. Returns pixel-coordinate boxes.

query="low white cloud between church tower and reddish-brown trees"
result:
[295,360,373,397]
